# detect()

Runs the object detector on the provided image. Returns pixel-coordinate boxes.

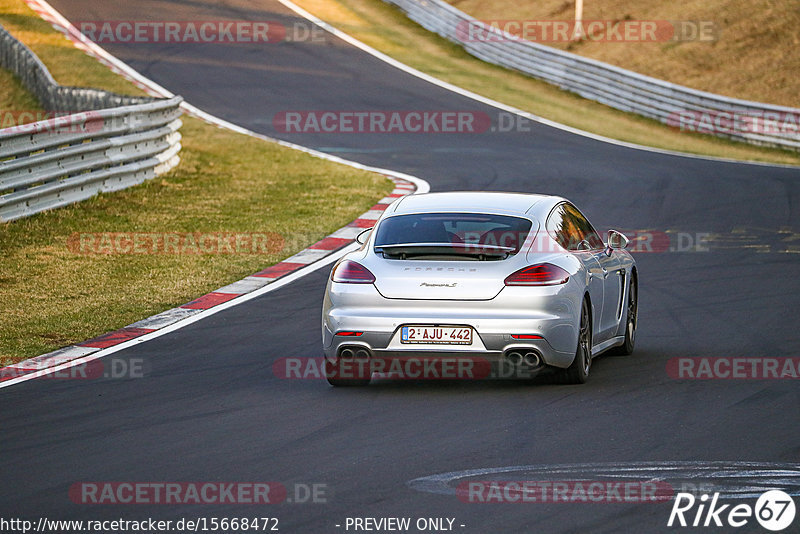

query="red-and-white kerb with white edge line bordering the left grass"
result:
[0,0,430,394]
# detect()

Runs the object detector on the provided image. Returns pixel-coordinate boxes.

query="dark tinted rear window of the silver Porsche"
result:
[375,213,531,259]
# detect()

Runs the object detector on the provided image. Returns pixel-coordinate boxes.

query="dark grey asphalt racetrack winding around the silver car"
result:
[0,0,800,533]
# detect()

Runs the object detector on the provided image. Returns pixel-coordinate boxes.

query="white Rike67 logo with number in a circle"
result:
[667,490,796,532]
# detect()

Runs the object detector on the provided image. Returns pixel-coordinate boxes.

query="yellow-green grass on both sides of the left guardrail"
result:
[0,0,392,364]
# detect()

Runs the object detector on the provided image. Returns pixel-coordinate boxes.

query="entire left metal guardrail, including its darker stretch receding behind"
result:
[0,26,183,222]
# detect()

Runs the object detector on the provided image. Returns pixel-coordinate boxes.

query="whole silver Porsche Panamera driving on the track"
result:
[322,192,638,386]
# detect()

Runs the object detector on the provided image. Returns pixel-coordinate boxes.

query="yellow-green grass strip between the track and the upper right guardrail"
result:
[294,0,800,165]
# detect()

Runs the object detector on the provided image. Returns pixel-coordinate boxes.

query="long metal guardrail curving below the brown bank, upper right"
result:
[384,0,800,150]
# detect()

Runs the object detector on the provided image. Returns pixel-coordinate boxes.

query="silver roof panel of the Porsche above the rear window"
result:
[387,191,565,218]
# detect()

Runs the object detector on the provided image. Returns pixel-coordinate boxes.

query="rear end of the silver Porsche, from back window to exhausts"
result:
[322,203,583,379]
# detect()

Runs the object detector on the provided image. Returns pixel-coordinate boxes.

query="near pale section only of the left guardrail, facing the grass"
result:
[0,97,183,222]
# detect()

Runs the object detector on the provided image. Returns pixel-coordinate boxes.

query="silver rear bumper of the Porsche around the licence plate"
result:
[322,282,583,368]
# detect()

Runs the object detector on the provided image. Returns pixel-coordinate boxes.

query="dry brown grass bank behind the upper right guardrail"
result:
[448,0,800,107]
